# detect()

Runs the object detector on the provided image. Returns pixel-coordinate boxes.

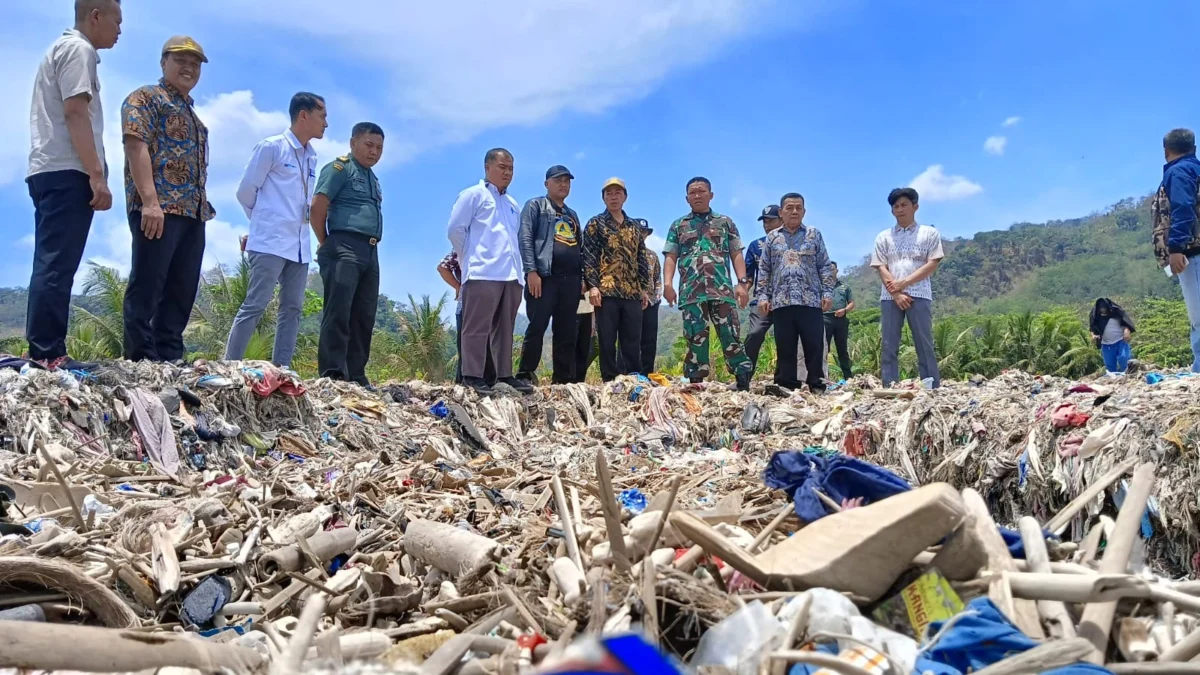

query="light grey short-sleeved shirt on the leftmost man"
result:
[29,29,108,177]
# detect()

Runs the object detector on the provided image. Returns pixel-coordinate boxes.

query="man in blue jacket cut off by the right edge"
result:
[1151,129,1200,372]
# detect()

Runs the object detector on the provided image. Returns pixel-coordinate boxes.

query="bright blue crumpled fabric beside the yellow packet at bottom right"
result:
[917,598,1111,675]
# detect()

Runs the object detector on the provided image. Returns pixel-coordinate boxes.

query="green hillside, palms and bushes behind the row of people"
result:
[0,193,1192,382]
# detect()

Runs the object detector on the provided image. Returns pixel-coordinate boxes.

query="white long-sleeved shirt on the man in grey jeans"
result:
[238,129,317,263]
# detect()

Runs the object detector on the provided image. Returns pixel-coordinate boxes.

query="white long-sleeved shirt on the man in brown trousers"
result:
[446,180,524,286]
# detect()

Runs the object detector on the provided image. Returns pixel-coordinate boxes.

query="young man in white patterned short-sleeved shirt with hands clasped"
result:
[871,187,946,388]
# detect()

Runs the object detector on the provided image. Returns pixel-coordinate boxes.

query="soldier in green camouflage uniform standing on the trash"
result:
[662,178,752,392]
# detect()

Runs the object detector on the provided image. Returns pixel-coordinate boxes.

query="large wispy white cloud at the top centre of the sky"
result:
[183,0,772,137]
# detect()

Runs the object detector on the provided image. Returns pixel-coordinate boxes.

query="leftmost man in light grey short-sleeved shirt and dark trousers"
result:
[25,0,121,370]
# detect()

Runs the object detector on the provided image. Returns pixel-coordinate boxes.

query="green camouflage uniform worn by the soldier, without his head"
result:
[662,210,752,381]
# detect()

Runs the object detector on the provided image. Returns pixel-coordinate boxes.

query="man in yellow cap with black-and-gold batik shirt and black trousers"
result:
[583,178,652,382]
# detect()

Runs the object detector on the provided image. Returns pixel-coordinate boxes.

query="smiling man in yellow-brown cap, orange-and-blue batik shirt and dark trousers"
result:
[121,36,216,362]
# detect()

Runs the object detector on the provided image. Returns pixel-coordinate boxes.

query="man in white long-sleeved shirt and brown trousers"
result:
[446,148,533,396]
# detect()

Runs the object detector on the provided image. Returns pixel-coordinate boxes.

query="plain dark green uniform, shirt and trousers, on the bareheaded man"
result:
[317,155,383,386]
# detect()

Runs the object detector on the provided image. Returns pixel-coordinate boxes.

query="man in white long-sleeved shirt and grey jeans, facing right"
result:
[224,91,329,366]
